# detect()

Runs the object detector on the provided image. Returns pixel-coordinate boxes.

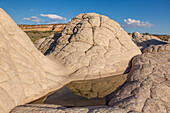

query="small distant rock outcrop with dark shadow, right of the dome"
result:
[131,32,167,51]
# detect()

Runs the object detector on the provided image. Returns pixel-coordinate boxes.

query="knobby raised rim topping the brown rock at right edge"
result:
[143,44,170,53]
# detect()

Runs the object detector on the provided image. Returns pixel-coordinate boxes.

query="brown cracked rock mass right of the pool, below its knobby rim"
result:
[109,51,170,113]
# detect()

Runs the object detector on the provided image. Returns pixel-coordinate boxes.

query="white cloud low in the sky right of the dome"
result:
[122,18,153,28]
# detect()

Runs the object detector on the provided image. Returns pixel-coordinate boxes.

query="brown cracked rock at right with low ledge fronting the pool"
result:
[12,51,170,113]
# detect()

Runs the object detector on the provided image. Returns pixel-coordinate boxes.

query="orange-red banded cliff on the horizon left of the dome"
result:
[18,24,65,31]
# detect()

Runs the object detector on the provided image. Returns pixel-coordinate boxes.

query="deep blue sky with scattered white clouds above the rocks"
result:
[0,0,170,34]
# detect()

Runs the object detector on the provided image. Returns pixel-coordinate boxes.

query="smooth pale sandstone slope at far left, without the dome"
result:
[0,9,72,113]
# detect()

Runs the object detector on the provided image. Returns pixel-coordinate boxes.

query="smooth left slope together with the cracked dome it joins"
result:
[0,9,140,113]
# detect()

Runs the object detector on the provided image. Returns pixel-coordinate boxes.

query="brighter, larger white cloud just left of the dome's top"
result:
[40,14,67,24]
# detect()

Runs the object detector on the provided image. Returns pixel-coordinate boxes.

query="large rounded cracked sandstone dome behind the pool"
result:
[40,13,141,79]
